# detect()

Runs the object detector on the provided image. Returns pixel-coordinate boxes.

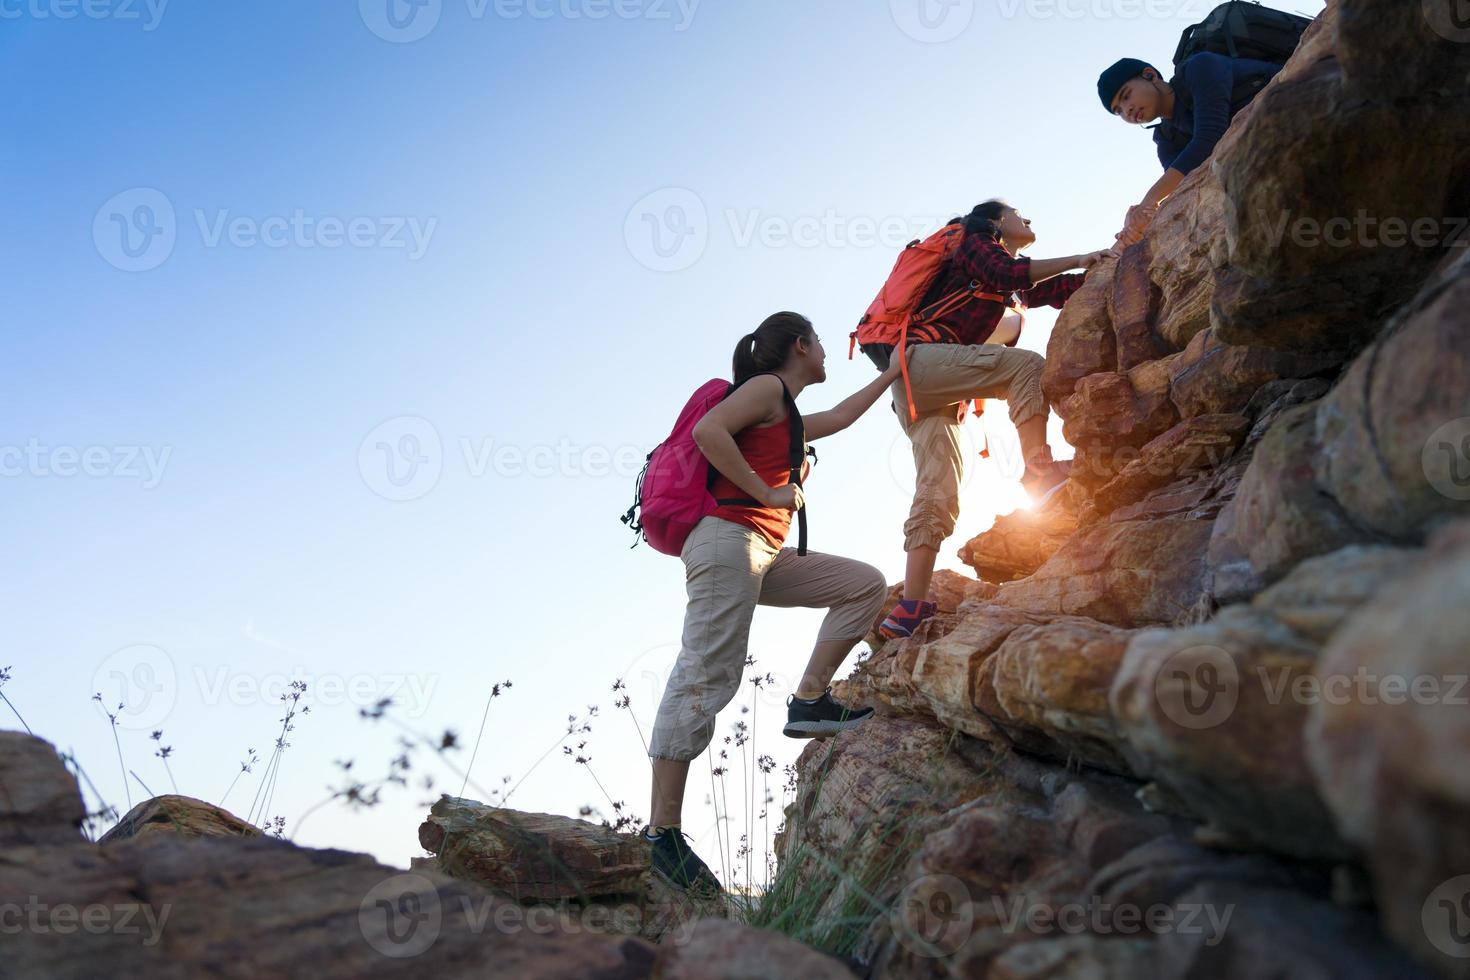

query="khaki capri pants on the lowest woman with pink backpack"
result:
[648,517,888,761]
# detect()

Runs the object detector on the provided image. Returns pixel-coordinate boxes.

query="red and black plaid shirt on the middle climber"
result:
[913,235,1086,347]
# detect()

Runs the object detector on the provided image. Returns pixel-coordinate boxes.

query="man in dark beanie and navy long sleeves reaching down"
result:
[1098,53,1282,245]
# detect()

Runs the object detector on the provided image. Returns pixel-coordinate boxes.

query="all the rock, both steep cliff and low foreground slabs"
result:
[0,0,1470,980]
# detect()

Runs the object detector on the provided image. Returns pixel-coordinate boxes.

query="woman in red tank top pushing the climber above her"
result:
[645,313,898,889]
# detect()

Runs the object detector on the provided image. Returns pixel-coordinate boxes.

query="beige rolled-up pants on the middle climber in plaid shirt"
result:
[892,344,1047,551]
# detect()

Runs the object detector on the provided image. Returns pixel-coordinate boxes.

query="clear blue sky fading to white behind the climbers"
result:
[0,0,1323,864]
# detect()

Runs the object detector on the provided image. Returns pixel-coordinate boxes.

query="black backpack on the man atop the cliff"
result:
[1154,0,1311,154]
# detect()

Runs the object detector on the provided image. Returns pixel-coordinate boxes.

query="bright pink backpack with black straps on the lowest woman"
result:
[622,378,807,555]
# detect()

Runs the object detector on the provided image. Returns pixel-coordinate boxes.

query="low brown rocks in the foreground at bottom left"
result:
[0,732,853,980]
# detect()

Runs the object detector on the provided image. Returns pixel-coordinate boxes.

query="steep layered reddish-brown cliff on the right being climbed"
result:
[781,0,1470,979]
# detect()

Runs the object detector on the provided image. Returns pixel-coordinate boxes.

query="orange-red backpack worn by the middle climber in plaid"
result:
[847,222,1010,431]
